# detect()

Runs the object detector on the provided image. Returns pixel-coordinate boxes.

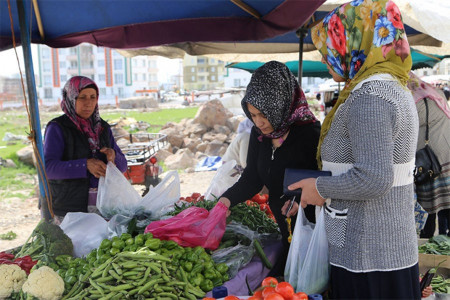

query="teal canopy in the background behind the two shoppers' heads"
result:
[225,48,450,78]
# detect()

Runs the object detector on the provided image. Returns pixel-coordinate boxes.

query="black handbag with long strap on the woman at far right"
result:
[414,98,442,185]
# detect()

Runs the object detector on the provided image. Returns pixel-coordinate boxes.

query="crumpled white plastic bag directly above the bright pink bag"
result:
[142,171,180,220]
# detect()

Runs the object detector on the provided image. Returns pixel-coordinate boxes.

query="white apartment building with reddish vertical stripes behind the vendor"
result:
[35,44,159,105]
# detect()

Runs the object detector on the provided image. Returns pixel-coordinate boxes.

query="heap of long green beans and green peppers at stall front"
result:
[51,233,229,299]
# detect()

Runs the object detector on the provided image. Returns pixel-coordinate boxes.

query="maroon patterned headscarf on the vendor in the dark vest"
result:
[61,76,101,152]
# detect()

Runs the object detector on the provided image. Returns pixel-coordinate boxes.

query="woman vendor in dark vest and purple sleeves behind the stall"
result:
[44,76,127,224]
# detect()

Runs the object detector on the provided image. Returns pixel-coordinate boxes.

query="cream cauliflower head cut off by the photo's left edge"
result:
[0,264,27,299]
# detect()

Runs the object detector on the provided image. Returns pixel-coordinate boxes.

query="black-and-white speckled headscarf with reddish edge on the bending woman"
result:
[241,61,317,140]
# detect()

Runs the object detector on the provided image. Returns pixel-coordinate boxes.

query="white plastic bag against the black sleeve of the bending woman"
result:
[205,159,240,200]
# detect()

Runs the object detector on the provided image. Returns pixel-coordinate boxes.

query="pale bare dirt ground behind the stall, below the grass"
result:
[0,171,216,251]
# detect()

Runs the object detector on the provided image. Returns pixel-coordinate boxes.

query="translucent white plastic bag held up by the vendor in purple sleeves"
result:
[97,162,141,219]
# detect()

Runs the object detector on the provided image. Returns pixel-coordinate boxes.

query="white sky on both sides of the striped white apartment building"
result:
[0,44,179,81]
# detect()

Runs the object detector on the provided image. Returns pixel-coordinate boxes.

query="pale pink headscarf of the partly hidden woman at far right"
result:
[408,72,450,119]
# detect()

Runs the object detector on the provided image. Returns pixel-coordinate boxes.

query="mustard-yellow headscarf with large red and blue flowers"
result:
[311,0,412,167]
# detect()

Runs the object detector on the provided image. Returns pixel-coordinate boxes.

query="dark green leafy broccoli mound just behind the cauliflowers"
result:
[16,220,73,263]
